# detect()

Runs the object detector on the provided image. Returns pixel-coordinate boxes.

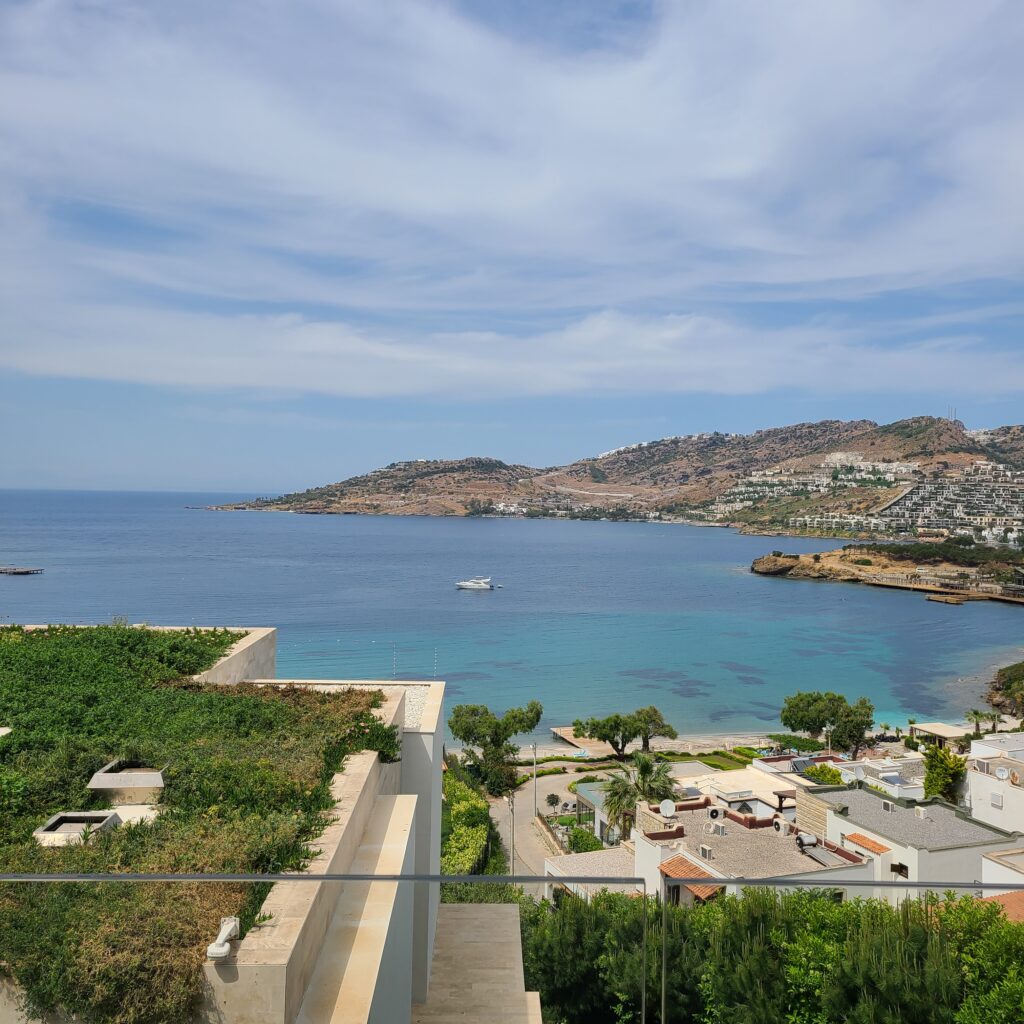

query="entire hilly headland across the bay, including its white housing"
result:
[221,417,1024,543]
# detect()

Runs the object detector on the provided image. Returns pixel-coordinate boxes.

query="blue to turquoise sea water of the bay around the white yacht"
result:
[0,492,1024,735]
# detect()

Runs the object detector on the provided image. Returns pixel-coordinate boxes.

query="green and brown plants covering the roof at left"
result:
[0,626,398,1024]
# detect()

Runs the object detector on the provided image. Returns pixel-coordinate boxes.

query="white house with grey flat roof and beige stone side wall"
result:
[797,782,1021,903]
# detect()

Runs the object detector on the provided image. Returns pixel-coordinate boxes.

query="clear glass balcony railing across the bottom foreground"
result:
[0,871,1024,1024]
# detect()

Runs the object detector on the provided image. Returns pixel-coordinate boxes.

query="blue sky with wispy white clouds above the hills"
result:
[0,0,1024,494]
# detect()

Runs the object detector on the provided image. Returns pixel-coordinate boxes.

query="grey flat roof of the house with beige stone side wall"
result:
[815,788,1009,850]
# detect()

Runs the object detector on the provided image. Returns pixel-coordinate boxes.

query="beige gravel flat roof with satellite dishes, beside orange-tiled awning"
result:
[650,808,855,879]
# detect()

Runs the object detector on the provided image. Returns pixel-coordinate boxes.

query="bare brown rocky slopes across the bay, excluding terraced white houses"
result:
[225,417,1024,515]
